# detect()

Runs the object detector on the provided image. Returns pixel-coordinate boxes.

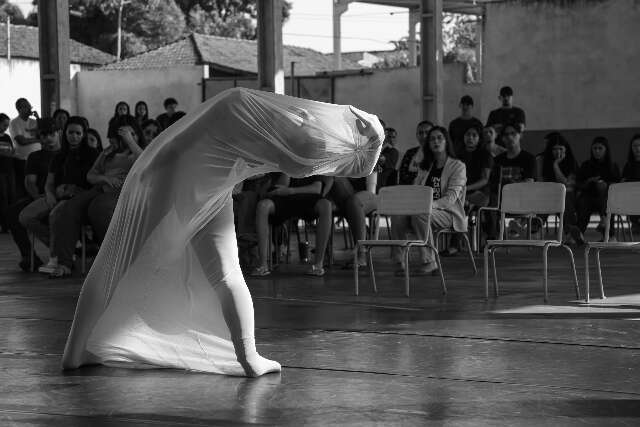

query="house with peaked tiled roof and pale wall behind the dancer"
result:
[76,33,362,140]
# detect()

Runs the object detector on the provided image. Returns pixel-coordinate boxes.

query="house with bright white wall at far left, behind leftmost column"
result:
[0,24,116,117]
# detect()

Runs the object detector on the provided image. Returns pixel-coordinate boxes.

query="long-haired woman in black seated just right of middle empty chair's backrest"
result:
[538,132,584,245]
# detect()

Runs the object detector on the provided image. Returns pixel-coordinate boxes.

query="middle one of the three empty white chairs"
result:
[484,182,580,302]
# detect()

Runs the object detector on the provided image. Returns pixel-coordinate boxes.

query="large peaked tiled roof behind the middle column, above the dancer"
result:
[102,33,362,75]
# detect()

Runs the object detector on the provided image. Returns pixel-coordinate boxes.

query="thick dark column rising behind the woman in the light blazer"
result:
[420,0,444,125]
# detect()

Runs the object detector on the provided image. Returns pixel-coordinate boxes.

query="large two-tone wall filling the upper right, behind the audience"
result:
[482,0,640,162]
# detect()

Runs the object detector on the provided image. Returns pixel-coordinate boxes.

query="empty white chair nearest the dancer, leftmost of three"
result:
[353,185,447,296]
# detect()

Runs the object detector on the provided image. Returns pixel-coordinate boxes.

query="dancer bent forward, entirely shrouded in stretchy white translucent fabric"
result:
[62,89,384,376]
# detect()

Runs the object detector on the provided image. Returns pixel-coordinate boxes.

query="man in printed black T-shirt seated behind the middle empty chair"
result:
[487,123,536,238]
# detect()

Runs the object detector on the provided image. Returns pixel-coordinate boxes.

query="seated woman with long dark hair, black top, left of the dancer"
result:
[19,117,98,273]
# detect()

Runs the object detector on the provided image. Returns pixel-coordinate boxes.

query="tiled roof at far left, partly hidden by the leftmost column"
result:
[0,24,116,65]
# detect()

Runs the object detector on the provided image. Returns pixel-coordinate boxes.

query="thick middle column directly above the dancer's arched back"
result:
[256,0,284,94]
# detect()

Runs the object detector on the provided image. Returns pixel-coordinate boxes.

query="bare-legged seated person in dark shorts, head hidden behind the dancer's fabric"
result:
[251,174,333,276]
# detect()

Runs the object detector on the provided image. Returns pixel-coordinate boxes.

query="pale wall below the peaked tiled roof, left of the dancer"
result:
[75,66,202,141]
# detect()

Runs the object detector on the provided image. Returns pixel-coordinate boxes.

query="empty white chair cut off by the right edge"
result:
[584,182,640,302]
